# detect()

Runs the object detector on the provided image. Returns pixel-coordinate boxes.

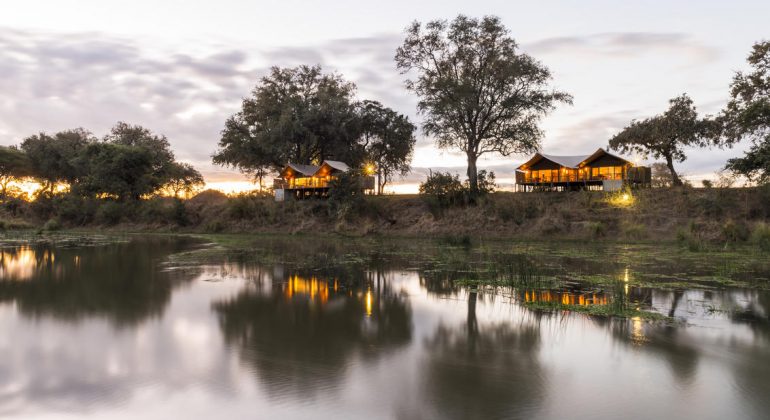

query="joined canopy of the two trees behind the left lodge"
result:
[213,66,415,192]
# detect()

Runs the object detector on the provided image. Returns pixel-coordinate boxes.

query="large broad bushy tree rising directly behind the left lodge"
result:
[213,66,364,180]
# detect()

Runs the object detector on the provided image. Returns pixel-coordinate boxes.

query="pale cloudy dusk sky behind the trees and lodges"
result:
[0,0,770,192]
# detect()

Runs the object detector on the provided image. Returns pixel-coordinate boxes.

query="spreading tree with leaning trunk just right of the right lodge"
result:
[609,94,710,186]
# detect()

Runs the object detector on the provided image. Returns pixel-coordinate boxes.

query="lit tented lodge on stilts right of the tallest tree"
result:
[516,148,650,191]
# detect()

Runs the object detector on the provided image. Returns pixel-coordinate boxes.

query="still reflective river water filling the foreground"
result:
[0,238,770,419]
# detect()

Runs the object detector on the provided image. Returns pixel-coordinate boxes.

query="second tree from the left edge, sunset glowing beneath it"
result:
[21,128,96,194]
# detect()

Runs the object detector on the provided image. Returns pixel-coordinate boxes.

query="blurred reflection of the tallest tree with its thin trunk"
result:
[425,292,544,419]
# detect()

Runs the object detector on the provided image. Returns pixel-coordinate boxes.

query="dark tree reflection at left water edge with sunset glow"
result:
[0,239,198,325]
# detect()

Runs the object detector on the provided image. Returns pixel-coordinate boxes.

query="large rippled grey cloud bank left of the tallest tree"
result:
[0,28,415,179]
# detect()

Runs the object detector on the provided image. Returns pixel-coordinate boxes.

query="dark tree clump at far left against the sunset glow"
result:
[12,122,198,201]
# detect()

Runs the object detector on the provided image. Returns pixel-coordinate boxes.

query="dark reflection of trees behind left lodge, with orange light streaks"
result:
[213,270,411,397]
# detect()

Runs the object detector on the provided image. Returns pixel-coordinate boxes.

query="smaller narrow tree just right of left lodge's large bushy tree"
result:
[358,101,417,194]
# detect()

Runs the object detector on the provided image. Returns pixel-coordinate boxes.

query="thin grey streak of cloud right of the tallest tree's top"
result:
[522,32,720,64]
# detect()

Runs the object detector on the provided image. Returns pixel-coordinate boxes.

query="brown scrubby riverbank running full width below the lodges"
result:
[0,187,770,248]
